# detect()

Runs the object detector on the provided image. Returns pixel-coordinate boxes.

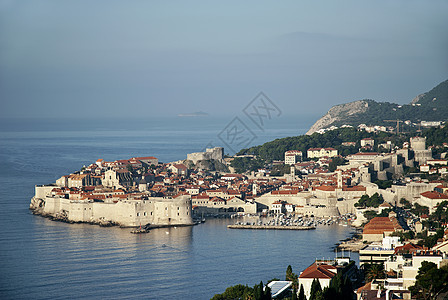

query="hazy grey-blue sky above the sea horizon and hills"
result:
[0,0,448,118]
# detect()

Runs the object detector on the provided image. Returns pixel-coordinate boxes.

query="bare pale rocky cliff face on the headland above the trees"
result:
[306,100,369,135]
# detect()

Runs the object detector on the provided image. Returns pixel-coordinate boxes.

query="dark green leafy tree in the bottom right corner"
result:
[409,261,448,299]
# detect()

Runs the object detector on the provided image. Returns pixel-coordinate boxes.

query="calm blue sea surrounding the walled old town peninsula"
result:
[0,113,358,299]
